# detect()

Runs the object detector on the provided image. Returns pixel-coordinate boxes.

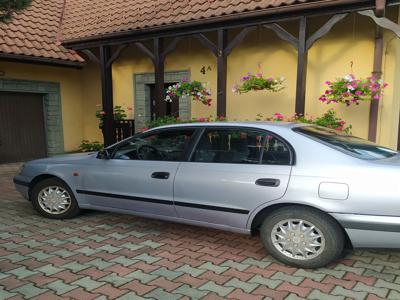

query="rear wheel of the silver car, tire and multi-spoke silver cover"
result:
[260,206,345,269]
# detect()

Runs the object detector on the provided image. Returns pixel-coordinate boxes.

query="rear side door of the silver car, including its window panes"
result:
[174,127,292,228]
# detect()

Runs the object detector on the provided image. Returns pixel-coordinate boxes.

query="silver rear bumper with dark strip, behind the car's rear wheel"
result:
[331,213,400,248]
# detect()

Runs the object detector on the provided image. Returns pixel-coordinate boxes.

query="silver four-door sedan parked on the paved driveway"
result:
[14,122,400,268]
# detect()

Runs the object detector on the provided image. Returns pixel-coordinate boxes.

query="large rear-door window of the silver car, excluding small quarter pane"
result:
[192,128,265,164]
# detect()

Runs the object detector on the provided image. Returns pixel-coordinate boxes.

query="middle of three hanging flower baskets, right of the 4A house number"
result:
[232,73,285,94]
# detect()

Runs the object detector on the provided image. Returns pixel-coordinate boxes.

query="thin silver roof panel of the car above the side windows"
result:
[152,121,307,129]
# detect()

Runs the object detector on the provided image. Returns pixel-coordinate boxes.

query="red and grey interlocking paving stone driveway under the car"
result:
[0,164,400,300]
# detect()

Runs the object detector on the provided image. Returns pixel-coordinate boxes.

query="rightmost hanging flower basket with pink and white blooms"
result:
[319,74,388,106]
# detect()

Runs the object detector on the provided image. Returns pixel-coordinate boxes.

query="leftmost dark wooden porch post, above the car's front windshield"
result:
[100,46,116,146]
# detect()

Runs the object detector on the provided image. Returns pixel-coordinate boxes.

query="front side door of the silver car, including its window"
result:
[78,129,194,216]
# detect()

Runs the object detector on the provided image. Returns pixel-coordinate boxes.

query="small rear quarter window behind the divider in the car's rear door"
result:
[262,134,291,165]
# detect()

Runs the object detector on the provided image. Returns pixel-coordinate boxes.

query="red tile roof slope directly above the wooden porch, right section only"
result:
[62,0,332,41]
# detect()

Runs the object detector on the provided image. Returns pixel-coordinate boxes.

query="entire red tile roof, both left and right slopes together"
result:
[0,0,367,62]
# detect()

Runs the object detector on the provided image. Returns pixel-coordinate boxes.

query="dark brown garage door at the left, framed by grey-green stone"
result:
[0,92,46,163]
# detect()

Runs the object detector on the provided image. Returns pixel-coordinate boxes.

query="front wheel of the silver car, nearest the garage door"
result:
[30,178,81,219]
